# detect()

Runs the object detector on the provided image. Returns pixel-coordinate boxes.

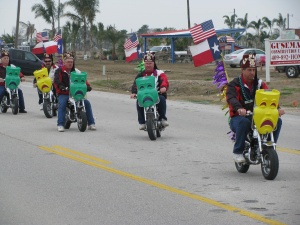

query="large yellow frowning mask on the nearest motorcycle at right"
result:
[253,89,280,134]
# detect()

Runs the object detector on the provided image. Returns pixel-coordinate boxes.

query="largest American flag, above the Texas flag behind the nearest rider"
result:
[190,20,216,44]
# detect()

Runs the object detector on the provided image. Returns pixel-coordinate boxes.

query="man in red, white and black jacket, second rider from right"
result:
[130,53,169,130]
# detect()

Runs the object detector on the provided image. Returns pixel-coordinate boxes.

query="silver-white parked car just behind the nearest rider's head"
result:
[224,48,266,68]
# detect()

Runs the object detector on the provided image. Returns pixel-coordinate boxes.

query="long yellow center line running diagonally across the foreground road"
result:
[39,146,285,225]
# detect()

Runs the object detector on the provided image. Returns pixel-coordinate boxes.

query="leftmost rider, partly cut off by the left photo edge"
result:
[0,50,27,113]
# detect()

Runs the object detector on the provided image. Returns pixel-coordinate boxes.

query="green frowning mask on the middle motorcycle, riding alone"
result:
[136,76,159,107]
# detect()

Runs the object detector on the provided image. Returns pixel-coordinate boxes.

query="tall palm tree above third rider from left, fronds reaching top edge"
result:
[64,0,99,54]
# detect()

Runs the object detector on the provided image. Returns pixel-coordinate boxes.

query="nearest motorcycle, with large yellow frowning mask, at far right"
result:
[235,89,280,180]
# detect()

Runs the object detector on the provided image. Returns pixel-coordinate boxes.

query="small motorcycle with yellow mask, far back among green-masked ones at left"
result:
[33,68,57,118]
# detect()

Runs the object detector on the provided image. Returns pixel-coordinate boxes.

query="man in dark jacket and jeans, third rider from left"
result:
[54,52,96,132]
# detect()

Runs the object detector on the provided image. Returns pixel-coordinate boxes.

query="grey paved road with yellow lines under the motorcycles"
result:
[0,83,300,225]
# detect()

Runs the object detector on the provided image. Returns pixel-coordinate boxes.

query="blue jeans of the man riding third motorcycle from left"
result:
[57,95,95,126]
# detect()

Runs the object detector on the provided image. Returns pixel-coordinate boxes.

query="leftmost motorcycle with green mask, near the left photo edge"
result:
[0,66,21,115]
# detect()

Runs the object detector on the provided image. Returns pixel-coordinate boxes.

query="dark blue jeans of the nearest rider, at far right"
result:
[230,116,282,154]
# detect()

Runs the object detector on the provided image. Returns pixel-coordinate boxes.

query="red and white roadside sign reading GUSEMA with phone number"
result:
[270,40,300,66]
